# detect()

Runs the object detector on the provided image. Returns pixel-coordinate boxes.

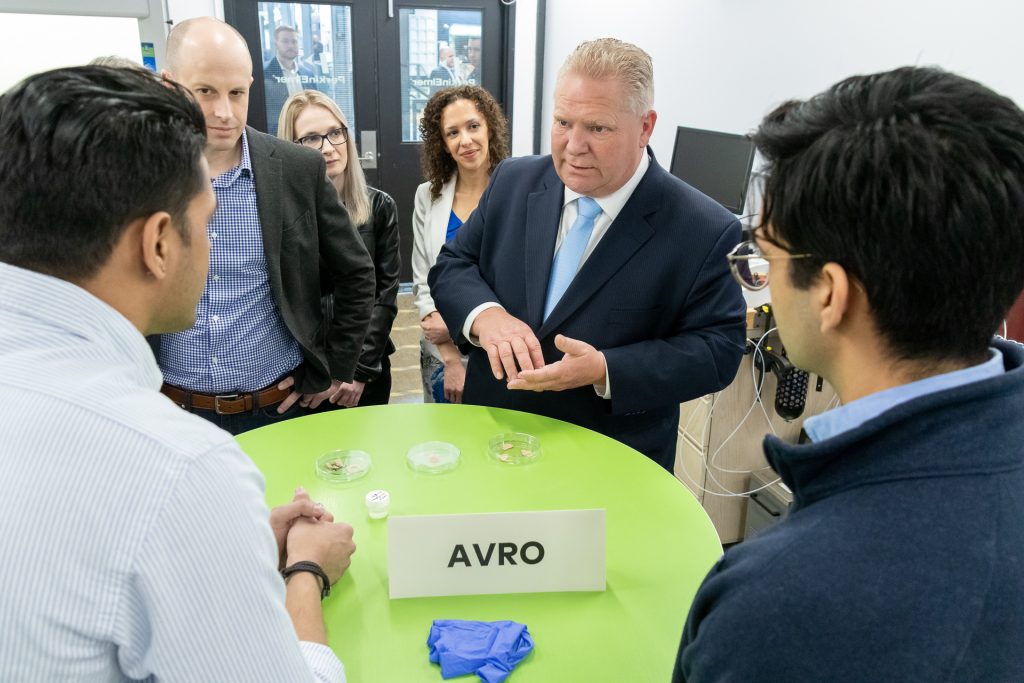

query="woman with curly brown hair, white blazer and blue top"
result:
[413,85,509,403]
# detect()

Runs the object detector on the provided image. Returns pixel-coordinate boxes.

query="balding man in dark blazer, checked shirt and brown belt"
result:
[157,17,375,433]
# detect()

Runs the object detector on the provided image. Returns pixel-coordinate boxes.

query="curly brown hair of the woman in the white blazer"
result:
[420,85,509,200]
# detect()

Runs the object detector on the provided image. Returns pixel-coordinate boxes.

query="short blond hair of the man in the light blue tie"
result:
[555,38,654,116]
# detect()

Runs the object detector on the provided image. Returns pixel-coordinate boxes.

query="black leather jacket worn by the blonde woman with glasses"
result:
[321,187,401,382]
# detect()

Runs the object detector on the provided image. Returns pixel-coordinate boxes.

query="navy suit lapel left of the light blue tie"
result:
[523,172,565,330]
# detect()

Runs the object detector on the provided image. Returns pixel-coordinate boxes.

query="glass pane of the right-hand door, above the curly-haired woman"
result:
[398,7,483,142]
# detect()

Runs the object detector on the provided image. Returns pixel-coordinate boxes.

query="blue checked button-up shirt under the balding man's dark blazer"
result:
[160,132,302,394]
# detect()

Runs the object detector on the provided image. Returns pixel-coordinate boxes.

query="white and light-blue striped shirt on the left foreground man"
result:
[0,263,344,683]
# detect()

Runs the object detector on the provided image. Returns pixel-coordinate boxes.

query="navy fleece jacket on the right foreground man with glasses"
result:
[673,339,1024,683]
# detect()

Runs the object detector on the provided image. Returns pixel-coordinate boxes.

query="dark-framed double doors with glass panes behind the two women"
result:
[224,0,515,283]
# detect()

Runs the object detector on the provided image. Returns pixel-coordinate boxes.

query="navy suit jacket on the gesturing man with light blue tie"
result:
[428,155,746,470]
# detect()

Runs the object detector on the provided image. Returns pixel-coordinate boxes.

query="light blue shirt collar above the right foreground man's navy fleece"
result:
[804,348,1006,441]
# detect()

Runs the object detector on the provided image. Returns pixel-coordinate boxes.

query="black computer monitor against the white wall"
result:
[671,126,754,215]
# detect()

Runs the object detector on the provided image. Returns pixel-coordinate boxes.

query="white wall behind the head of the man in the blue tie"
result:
[540,0,1024,159]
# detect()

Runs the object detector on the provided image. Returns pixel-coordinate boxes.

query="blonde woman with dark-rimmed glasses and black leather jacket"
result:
[278,90,400,409]
